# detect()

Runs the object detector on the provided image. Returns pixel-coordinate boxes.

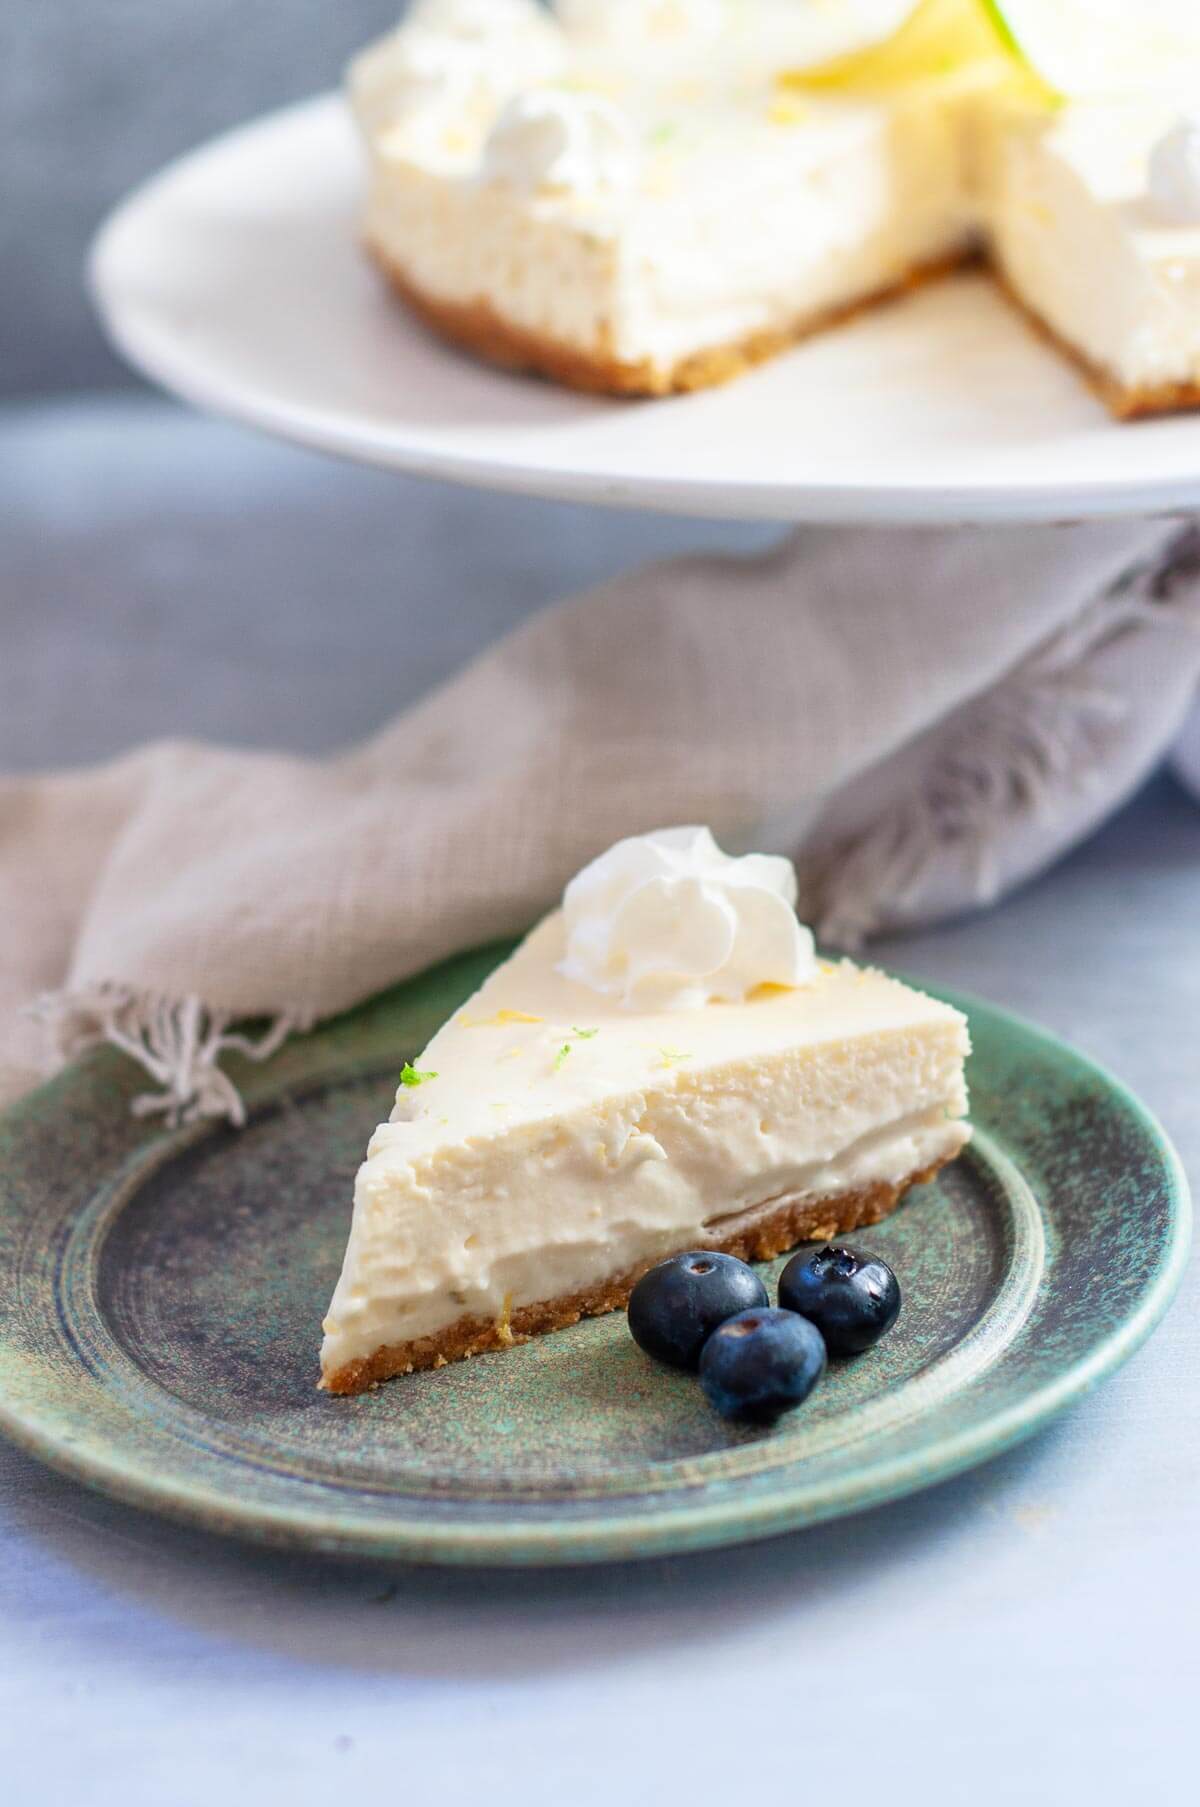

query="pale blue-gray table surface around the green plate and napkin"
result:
[0,403,1200,1807]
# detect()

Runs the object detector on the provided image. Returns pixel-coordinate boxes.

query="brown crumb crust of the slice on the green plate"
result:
[320,1155,954,1393]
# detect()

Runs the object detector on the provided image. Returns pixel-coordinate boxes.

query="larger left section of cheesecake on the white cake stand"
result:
[351,0,978,394]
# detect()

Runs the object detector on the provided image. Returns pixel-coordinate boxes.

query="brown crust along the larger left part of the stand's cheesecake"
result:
[367,240,978,396]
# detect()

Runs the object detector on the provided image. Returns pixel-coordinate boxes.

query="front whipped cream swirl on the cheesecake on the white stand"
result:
[479,89,638,195]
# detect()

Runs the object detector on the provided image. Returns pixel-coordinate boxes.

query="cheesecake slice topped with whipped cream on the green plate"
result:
[322,829,969,1393]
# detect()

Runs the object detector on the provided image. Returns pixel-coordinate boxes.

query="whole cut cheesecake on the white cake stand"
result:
[349,0,1200,416]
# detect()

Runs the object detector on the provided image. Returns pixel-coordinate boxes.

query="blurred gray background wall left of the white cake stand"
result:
[0,0,403,396]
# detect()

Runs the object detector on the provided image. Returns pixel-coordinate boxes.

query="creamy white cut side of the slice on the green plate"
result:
[322,1004,969,1375]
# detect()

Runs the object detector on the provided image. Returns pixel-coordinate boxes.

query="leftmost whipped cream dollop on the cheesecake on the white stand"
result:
[347,0,567,134]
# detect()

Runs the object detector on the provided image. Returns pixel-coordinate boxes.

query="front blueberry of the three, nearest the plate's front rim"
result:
[699,1306,826,1424]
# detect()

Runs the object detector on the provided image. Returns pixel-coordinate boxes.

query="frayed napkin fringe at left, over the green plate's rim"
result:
[31,985,313,1129]
